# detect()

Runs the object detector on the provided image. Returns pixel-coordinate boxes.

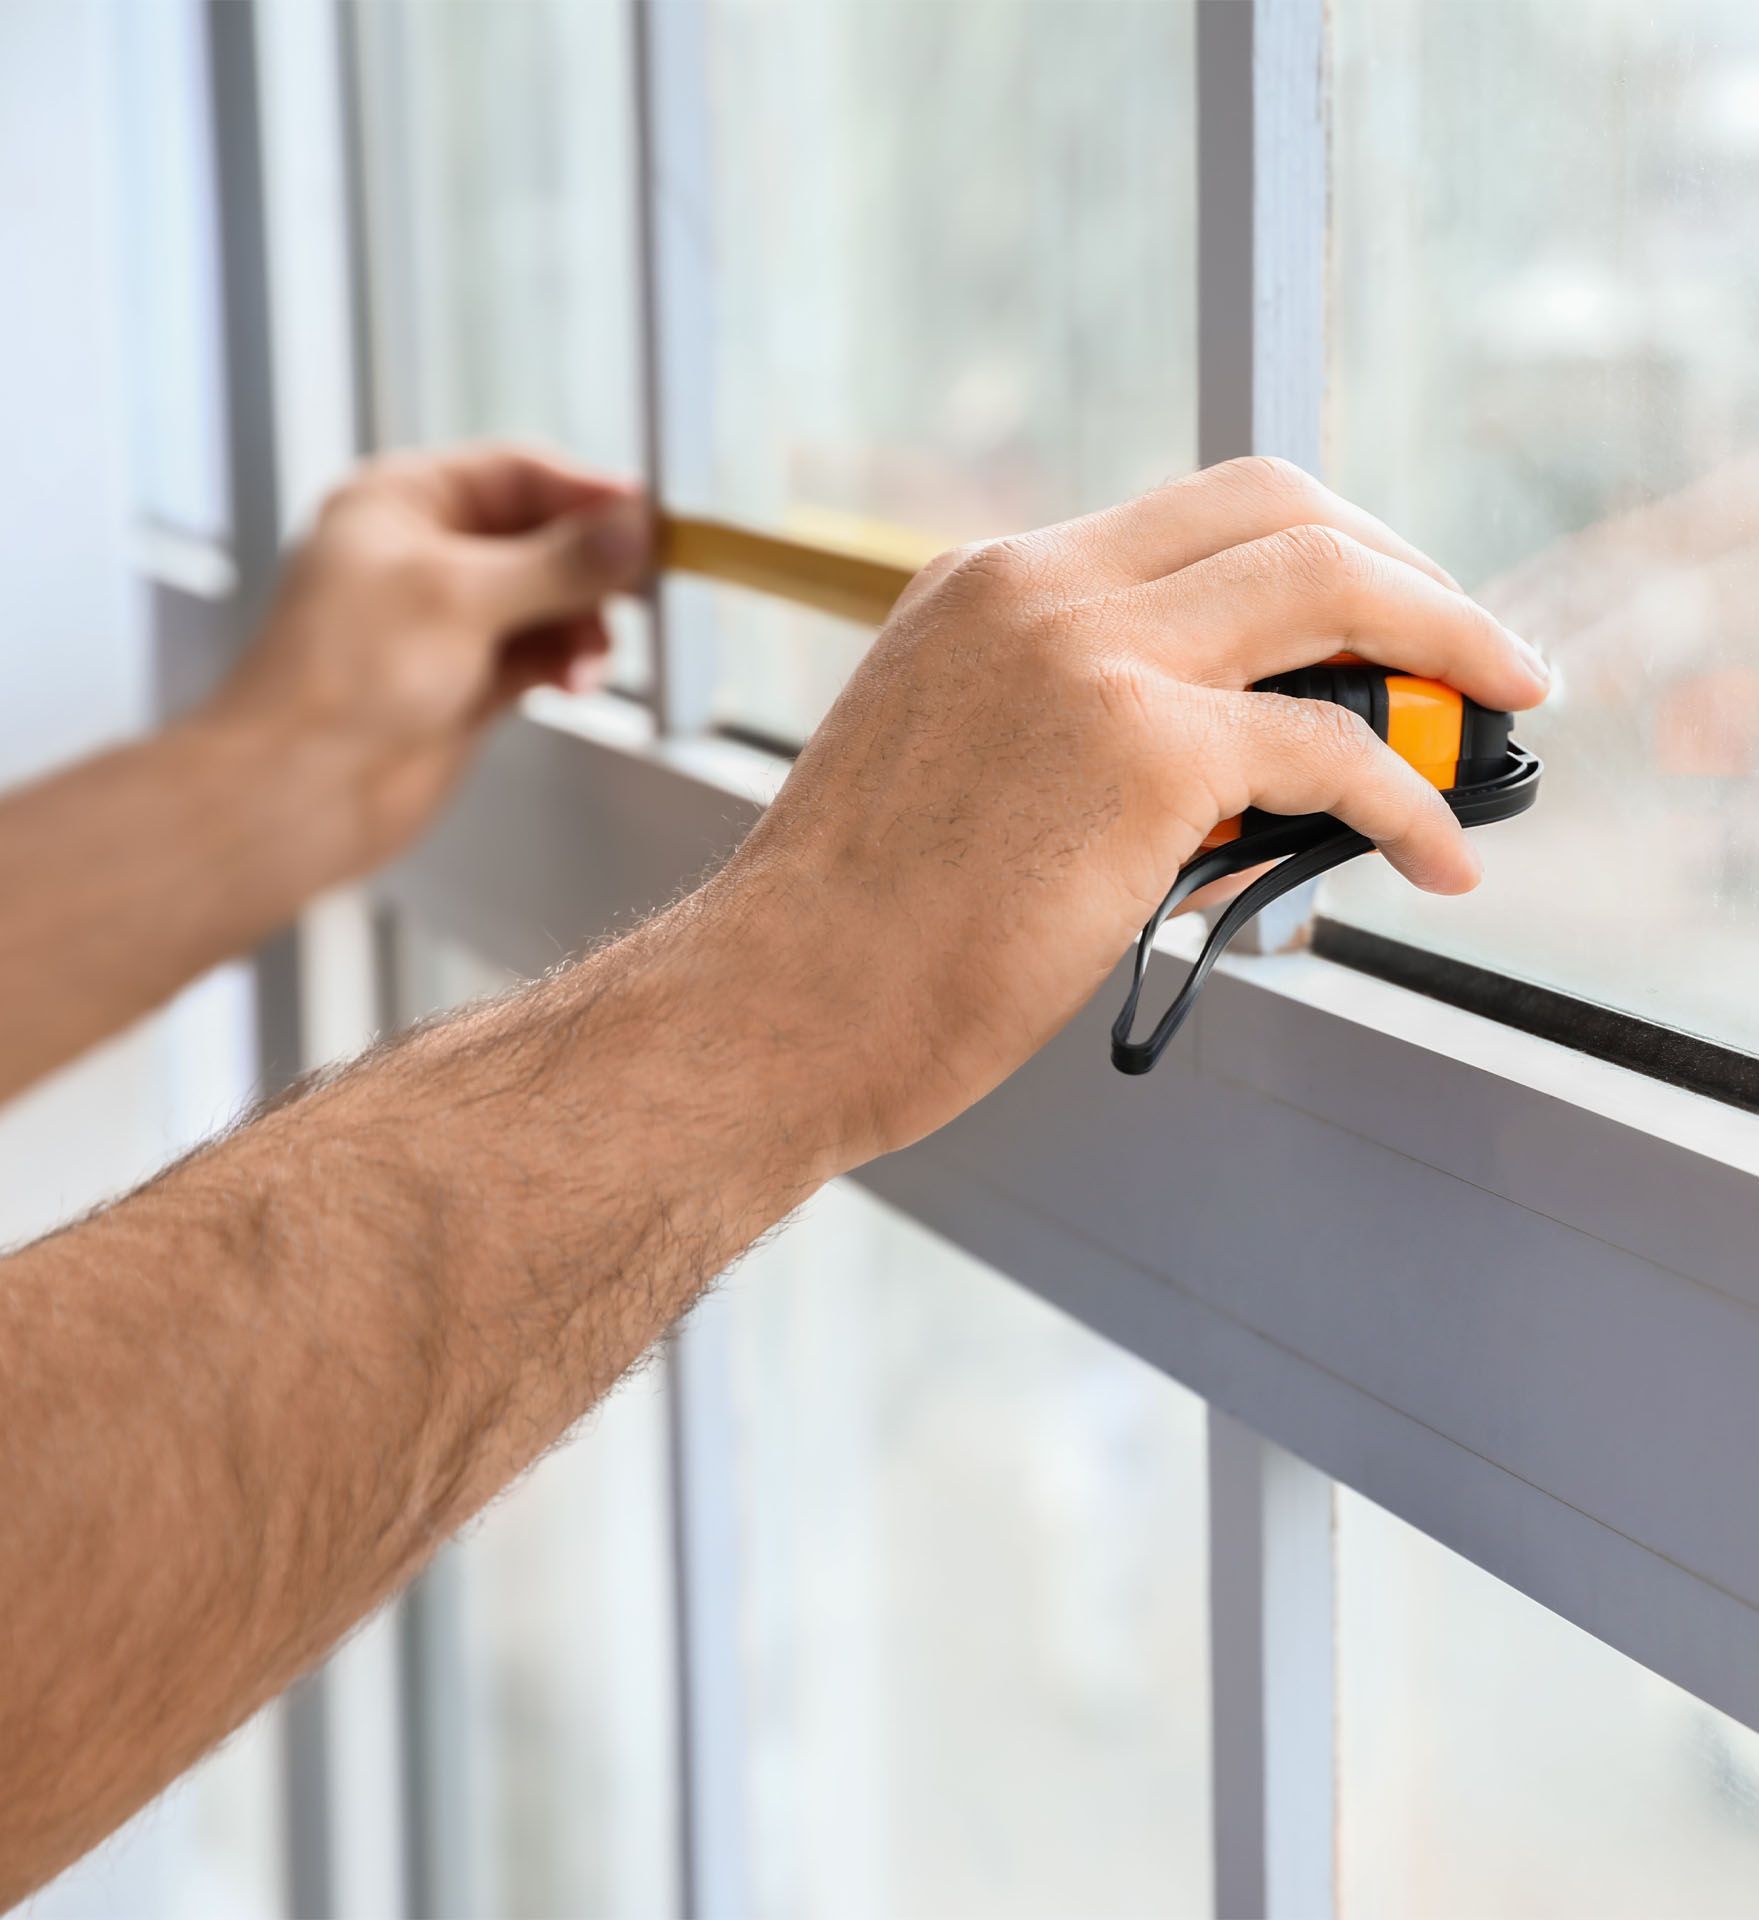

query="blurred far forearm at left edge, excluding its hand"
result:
[0,712,357,1098]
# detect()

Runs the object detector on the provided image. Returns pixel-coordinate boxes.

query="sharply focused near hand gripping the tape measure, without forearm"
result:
[716,459,1548,1164]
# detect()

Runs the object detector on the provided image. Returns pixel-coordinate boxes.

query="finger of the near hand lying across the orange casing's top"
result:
[1116,524,1550,708]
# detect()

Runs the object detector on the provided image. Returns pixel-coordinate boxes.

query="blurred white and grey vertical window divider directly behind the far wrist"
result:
[204,0,430,1920]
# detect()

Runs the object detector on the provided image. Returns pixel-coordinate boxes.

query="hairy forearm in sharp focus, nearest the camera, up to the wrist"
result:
[0,879,849,1905]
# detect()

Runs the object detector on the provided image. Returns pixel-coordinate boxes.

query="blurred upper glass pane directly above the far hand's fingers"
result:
[353,0,647,685]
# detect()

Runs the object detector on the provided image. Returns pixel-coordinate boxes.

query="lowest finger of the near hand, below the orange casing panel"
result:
[1217,693,1482,893]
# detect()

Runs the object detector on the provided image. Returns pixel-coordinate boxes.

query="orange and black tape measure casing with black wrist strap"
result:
[1112,653,1544,1073]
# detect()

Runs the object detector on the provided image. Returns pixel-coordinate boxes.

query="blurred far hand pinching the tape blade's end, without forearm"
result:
[205,447,651,879]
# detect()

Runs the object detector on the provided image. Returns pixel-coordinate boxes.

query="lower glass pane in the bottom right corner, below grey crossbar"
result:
[1338,1490,1759,1920]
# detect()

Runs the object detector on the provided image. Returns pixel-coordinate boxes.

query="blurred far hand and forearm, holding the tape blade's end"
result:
[0,447,649,1098]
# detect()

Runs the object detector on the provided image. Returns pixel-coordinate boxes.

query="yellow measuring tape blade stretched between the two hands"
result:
[659,513,941,626]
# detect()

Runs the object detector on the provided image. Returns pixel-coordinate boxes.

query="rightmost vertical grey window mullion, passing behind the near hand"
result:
[1196,0,1335,1920]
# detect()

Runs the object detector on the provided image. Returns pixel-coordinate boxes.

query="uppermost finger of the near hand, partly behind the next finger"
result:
[1029,457,1459,597]
